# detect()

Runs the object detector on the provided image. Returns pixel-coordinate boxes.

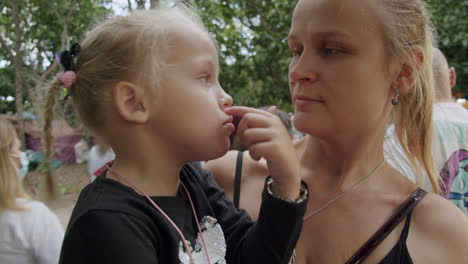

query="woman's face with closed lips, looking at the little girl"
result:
[288,0,398,140]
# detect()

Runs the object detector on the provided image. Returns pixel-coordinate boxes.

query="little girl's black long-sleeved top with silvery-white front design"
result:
[60,165,307,264]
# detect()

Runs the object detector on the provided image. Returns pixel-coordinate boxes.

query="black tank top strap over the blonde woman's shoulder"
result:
[346,188,427,264]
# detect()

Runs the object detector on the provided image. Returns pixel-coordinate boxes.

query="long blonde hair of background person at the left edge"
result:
[0,118,30,210]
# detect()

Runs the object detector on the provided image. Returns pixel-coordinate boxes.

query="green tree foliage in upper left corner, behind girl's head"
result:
[0,0,110,114]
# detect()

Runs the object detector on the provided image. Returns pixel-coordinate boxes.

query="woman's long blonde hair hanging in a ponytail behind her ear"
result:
[376,0,440,193]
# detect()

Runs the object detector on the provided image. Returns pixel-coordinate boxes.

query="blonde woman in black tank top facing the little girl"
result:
[210,0,468,264]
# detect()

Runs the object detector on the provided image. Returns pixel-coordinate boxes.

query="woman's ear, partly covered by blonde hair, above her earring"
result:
[394,47,425,94]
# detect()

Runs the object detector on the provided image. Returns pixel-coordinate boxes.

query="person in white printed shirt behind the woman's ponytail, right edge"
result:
[384,48,468,215]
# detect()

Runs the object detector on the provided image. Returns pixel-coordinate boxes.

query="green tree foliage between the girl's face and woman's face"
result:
[192,0,295,111]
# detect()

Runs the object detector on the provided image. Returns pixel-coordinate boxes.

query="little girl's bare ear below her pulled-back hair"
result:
[112,82,149,124]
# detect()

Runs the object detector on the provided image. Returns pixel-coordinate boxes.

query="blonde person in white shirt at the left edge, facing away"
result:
[0,119,64,264]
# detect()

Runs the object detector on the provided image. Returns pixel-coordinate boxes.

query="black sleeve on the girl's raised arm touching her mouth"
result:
[199,167,308,264]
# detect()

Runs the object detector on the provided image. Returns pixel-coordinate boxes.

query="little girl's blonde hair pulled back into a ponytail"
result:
[44,4,207,191]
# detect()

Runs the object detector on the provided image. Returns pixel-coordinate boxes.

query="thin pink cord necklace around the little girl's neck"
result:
[106,164,211,264]
